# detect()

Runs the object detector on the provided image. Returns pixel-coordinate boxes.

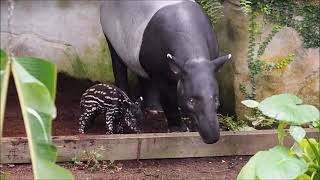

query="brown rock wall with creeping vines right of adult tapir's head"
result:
[215,0,320,117]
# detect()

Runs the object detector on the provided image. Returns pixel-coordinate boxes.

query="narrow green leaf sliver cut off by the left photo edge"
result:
[0,49,10,138]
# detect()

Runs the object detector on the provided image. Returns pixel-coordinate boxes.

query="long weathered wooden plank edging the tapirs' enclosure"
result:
[0,129,318,163]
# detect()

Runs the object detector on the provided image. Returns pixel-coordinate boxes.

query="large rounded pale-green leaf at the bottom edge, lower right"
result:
[237,146,307,180]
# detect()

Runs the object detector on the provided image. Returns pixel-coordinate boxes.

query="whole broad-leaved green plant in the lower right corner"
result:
[237,94,320,180]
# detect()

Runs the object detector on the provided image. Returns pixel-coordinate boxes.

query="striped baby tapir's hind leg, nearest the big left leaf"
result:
[79,107,98,134]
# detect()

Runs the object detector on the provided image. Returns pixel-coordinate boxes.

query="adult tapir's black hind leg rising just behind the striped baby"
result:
[106,37,128,93]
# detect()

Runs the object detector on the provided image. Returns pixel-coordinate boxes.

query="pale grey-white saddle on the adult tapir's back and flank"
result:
[101,0,193,77]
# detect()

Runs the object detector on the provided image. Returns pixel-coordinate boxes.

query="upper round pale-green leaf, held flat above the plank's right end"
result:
[258,94,319,125]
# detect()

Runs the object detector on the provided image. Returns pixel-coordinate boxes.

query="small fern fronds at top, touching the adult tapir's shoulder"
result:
[196,0,223,24]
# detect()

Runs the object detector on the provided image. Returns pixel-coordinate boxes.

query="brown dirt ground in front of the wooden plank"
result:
[0,156,249,180]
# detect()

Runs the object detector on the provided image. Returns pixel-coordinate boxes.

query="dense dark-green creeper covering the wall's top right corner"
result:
[241,0,320,48]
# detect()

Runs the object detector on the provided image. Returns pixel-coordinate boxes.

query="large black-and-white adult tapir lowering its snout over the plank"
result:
[100,0,231,144]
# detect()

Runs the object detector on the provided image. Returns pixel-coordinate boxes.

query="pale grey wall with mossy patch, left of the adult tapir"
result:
[0,0,113,81]
